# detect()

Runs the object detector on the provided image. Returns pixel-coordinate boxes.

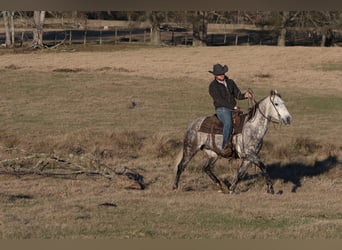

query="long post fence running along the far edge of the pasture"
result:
[0,27,342,46]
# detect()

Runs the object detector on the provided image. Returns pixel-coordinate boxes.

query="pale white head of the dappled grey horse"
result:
[268,90,292,125]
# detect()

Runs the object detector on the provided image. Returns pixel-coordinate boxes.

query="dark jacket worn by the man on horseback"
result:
[209,76,246,110]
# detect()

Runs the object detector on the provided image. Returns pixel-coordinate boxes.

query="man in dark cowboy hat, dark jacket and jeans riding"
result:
[209,64,252,156]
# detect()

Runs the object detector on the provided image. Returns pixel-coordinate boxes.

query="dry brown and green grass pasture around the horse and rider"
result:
[0,44,342,239]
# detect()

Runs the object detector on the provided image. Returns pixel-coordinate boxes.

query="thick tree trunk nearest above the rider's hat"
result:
[192,11,208,46]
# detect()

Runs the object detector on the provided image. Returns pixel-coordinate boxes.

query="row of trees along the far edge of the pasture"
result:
[1,11,342,48]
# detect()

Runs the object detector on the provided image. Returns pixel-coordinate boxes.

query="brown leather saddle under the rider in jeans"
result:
[199,110,247,135]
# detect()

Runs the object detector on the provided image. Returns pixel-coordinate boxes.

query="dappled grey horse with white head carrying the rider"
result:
[173,90,292,194]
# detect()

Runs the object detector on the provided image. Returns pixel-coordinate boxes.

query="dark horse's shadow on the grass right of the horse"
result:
[260,156,341,193]
